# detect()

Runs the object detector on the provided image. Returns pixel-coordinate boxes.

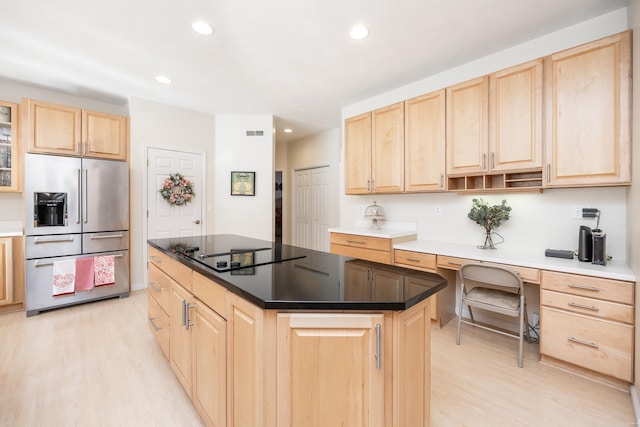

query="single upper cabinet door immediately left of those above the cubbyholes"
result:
[404,89,446,192]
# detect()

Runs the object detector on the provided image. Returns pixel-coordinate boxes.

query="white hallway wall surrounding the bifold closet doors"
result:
[282,128,342,244]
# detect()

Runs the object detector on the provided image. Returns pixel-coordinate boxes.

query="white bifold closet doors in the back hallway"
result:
[293,166,330,251]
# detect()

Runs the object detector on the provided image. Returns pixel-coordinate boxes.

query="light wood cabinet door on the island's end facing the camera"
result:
[276,313,384,427]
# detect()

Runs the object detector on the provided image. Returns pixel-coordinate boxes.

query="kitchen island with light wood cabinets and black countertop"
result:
[148,235,446,427]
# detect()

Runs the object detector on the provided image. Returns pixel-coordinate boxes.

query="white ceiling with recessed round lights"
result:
[0,0,628,142]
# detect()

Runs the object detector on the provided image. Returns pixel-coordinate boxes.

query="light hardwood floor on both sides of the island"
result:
[0,291,635,427]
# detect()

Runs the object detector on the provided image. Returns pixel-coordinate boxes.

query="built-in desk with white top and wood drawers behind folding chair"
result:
[394,240,636,389]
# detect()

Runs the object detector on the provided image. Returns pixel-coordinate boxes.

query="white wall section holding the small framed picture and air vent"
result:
[214,115,275,240]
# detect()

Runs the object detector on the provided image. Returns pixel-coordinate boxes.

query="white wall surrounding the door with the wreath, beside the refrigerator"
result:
[129,98,215,290]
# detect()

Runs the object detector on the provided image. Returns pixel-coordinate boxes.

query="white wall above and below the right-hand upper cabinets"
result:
[340,9,627,260]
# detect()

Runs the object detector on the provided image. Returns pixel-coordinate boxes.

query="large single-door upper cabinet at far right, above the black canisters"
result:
[545,32,631,187]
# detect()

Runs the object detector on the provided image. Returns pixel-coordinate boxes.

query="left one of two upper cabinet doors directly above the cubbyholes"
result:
[447,76,489,175]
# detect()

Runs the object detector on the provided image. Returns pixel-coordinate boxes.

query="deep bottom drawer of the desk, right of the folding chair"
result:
[540,307,633,382]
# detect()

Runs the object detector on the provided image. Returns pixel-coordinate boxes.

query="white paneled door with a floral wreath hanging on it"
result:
[147,148,205,239]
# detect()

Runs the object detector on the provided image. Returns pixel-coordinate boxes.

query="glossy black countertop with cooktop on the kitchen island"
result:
[148,234,447,311]
